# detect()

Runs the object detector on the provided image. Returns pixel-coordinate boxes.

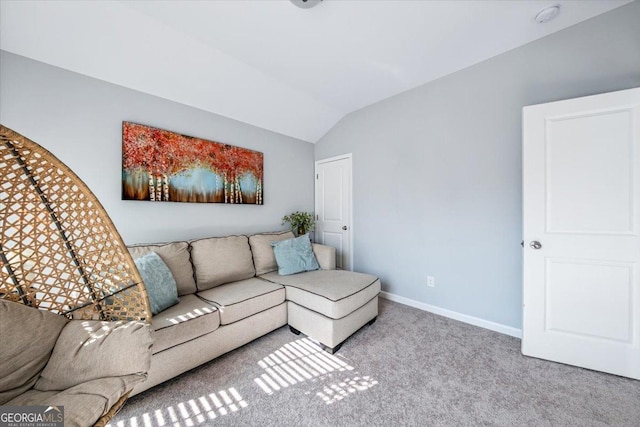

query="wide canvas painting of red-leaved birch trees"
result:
[122,122,263,205]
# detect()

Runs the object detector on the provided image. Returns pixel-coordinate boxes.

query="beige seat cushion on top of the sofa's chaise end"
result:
[260,270,380,319]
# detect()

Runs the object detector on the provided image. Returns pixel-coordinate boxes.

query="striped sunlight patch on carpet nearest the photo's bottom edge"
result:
[106,387,248,427]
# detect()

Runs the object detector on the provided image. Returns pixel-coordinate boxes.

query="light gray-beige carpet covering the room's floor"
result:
[111,300,640,427]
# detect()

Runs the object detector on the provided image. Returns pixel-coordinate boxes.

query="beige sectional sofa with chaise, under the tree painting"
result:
[129,232,380,394]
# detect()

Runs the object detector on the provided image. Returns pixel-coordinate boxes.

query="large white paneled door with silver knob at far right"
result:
[522,88,640,379]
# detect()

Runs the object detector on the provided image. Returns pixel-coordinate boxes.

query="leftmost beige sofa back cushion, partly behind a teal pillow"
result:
[127,242,196,296]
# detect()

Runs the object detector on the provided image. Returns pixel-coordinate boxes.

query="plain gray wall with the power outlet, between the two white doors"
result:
[315,2,640,328]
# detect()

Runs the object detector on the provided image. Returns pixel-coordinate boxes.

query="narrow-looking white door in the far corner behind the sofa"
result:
[315,154,353,270]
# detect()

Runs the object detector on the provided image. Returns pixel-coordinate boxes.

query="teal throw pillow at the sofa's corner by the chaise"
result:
[271,234,320,276]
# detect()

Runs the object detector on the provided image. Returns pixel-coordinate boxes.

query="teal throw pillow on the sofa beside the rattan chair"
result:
[134,252,180,314]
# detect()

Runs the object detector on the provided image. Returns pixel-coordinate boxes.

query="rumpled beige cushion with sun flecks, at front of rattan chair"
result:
[34,320,153,391]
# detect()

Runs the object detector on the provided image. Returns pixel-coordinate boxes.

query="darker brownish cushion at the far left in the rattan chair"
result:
[0,299,68,405]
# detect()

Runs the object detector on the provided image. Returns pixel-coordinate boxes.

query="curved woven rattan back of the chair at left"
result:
[0,125,151,321]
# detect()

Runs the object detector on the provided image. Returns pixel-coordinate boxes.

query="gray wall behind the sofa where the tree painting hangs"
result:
[0,52,314,243]
